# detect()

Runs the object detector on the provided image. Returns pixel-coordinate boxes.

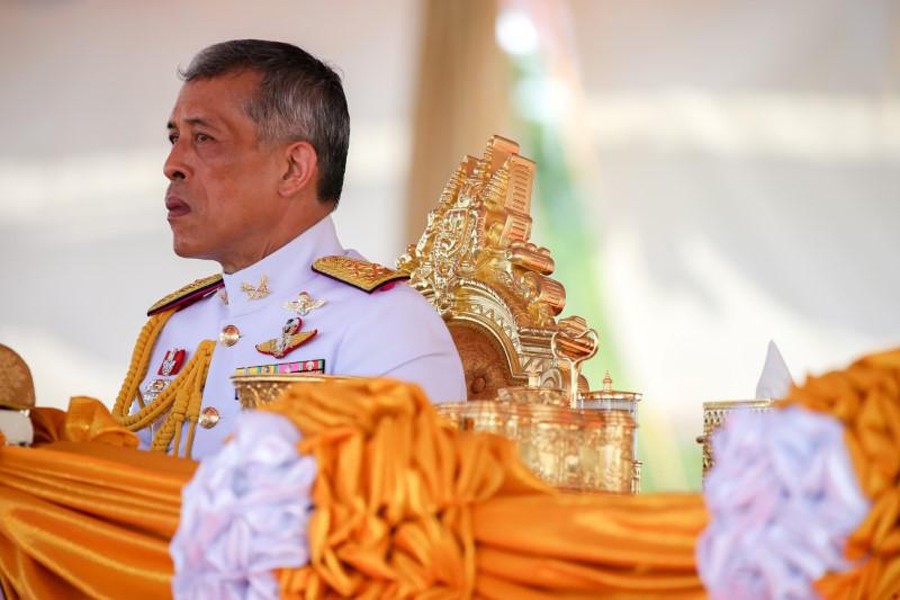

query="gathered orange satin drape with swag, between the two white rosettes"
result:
[265,380,707,598]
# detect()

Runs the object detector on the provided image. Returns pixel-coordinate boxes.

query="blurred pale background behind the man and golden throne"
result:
[0,0,900,490]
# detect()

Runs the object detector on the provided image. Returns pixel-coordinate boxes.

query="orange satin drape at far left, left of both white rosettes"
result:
[0,398,196,600]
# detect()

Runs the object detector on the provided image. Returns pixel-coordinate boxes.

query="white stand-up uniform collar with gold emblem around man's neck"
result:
[222,216,344,316]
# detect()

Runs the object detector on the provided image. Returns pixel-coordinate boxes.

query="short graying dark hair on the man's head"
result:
[178,40,350,204]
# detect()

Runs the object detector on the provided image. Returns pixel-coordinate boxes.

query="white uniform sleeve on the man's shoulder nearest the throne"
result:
[334,284,466,403]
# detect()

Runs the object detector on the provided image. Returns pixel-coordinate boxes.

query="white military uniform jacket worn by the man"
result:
[140,217,466,460]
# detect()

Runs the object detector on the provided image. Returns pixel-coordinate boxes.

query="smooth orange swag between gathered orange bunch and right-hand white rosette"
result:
[473,494,706,597]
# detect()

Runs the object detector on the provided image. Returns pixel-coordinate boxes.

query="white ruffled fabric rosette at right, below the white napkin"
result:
[697,407,869,600]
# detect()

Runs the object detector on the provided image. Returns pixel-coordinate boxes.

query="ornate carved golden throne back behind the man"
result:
[397,136,596,400]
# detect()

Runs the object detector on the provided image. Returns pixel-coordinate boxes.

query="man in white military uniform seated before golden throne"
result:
[114,40,465,459]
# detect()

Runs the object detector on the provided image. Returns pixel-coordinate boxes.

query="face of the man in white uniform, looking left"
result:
[163,71,285,272]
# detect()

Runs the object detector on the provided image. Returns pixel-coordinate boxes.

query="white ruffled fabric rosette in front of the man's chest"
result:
[170,411,316,600]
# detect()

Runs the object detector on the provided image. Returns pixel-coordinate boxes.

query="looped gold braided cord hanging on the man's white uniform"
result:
[113,309,216,456]
